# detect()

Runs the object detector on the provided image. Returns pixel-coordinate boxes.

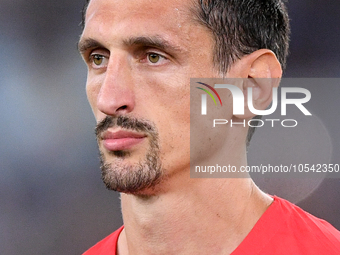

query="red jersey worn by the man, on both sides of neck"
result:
[83,197,340,255]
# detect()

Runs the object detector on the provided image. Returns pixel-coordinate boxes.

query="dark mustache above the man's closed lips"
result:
[95,116,156,138]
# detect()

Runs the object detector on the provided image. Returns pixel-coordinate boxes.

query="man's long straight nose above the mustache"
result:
[97,56,135,116]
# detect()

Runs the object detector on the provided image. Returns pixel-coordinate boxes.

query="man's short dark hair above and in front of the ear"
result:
[81,0,290,145]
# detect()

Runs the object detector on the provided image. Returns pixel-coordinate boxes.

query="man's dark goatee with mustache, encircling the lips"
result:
[96,116,164,195]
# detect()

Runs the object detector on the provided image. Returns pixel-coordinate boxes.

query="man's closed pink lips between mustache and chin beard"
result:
[102,130,146,151]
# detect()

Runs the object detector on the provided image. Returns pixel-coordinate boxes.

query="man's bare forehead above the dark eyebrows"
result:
[83,0,198,40]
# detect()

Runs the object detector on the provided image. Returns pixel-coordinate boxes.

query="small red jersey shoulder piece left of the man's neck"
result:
[83,226,124,255]
